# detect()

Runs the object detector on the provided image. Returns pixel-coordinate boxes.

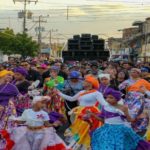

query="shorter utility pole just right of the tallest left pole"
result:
[33,15,48,49]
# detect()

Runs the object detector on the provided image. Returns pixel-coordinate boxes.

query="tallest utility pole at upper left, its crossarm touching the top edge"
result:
[13,0,38,33]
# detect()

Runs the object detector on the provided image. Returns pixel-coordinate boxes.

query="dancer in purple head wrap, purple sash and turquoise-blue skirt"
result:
[91,90,150,150]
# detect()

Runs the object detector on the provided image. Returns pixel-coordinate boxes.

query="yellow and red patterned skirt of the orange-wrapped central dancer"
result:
[65,106,102,149]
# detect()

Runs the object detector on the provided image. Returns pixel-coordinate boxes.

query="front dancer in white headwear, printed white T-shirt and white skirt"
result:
[5,96,67,150]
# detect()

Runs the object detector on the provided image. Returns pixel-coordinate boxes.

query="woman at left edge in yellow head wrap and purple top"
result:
[0,70,19,149]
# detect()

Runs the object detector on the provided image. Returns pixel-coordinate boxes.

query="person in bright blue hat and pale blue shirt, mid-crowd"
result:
[63,71,83,123]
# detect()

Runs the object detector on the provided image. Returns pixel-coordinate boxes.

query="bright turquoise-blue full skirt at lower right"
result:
[91,124,143,150]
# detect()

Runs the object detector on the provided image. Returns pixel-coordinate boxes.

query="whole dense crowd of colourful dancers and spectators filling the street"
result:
[0,58,150,150]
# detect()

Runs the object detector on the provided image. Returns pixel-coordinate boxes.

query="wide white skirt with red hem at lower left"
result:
[1,126,69,150]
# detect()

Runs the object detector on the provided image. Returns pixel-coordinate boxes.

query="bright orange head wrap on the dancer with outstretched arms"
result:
[85,75,99,89]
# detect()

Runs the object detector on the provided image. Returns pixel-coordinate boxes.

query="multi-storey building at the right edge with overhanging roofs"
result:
[122,18,150,61]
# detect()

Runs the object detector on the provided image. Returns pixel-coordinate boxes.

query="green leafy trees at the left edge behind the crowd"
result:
[0,28,39,57]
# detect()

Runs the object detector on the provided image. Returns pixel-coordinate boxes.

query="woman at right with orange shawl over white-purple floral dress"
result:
[119,68,150,136]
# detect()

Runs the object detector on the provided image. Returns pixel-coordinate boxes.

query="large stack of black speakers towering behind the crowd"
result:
[62,34,109,61]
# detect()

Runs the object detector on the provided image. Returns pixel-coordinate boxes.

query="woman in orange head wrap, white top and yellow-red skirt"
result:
[58,75,107,149]
